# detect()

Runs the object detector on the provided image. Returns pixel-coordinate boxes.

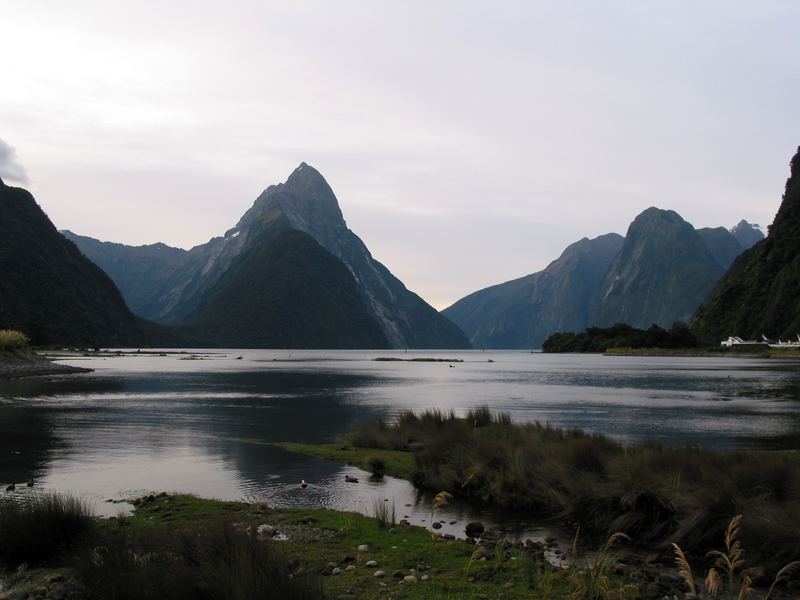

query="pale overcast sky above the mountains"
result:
[0,0,800,309]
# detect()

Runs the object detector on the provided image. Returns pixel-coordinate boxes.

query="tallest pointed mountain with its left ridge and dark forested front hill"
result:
[62,163,470,348]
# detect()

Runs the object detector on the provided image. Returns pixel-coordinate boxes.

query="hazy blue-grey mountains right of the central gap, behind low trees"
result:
[443,207,763,348]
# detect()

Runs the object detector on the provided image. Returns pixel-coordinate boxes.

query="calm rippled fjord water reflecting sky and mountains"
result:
[0,350,800,532]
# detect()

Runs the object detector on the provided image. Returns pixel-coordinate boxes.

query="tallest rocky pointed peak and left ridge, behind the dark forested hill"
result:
[72,163,469,348]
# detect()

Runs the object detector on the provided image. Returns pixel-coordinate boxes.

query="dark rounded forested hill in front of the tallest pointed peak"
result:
[186,219,388,348]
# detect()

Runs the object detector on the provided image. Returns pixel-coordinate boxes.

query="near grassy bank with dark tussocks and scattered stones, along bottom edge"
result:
[0,494,648,600]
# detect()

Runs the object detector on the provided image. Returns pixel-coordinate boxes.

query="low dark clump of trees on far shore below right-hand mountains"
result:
[542,322,698,352]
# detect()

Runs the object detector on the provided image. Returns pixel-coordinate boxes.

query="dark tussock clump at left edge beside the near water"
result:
[0,493,96,566]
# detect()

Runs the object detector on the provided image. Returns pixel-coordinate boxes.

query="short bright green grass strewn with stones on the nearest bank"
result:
[128,495,580,600]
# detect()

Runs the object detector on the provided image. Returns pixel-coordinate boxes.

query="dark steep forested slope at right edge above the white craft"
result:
[692,148,800,343]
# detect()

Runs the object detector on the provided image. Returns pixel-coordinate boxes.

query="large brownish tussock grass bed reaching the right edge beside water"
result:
[349,408,800,569]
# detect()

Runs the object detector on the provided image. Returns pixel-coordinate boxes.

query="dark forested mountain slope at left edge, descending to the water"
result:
[0,180,162,346]
